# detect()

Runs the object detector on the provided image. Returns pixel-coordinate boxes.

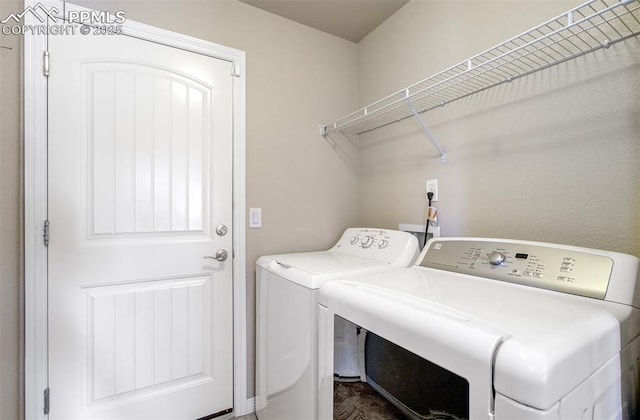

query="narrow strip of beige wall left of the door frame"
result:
[0,0,23,419]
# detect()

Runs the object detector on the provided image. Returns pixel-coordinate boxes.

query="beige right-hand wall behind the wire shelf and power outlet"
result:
[359,0,640,255]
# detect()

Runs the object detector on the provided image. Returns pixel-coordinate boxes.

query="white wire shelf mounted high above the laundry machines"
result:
[321,0,640,136]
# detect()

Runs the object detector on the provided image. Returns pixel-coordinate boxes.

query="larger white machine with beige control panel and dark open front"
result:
[318,238,640,420]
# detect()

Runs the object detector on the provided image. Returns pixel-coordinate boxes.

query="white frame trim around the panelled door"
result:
[23,0,248,420]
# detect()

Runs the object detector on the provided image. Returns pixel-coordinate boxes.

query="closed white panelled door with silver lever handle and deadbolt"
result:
[48,18,233,420]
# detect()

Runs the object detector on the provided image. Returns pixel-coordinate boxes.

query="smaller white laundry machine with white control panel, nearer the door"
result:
[256,228,419,420]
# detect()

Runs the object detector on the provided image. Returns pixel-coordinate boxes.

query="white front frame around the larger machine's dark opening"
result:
[319,280,504,418]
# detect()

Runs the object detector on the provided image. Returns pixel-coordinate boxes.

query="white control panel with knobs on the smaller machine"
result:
[331,228,420,265]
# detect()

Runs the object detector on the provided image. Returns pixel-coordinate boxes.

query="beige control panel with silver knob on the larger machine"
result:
[419,239,613,299]
